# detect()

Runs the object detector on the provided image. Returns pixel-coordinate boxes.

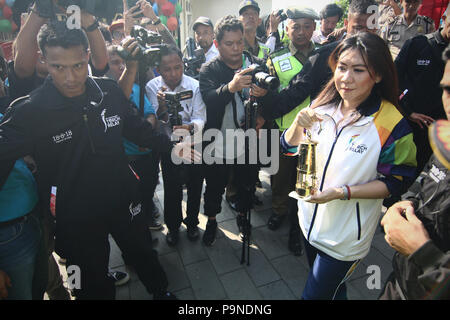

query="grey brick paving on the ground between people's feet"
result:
[51,171,394,300]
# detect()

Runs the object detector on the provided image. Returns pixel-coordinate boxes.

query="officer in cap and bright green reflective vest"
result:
[267,8,319,255]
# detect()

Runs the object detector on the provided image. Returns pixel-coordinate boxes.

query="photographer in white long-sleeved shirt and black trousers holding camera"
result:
[146,46,206,245]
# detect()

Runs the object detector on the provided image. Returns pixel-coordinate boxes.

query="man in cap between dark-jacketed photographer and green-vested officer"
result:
[239,0,270,59]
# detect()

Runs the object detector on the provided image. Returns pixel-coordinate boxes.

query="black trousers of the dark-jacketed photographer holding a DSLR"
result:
[203,164,259,217]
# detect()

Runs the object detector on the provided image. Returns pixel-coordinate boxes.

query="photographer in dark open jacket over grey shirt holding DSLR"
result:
[200,16,267,246]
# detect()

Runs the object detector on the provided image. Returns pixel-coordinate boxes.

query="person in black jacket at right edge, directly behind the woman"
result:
[395,12,450,174]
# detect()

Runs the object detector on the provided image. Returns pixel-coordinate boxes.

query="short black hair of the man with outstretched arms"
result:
[37,22,89,56]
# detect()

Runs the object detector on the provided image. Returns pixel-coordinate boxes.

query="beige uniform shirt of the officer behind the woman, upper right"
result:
[380,15,435,60]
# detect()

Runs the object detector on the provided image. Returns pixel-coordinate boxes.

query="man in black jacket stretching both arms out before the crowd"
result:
[0,23,173,299]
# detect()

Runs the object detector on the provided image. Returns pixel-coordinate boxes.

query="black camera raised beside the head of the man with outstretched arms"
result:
[118,26,162,67]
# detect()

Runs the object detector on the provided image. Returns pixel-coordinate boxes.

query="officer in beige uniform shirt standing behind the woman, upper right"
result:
[380,0,435,60]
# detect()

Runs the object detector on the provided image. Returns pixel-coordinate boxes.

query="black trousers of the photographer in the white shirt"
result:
[161,153,203,230]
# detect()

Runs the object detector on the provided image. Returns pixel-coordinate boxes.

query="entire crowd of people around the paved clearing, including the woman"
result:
[0,0,450,300]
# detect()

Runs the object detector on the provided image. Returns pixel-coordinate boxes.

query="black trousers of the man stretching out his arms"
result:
[56,198,168,300]
